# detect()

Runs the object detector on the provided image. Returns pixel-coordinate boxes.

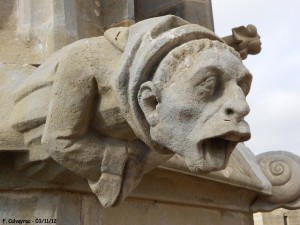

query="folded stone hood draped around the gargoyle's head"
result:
[112,15,223,153]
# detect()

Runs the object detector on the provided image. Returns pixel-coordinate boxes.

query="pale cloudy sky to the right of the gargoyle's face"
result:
[212,0,300,155]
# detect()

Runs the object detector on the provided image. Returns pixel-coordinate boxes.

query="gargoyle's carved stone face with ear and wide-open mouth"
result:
[139,40,252,172]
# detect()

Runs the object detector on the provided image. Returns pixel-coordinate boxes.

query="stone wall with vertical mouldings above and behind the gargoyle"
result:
[0,0,213,64]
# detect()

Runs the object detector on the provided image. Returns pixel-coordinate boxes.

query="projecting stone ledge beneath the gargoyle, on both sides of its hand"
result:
[0,146,272,212]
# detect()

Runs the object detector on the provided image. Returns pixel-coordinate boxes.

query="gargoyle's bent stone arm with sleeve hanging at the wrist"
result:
[42,62,128,207]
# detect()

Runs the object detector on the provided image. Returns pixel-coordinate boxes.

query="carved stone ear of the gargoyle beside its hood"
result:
[138,81,159,127]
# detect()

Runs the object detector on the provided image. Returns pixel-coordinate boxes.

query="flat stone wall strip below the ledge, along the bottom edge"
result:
[0,191,252,225]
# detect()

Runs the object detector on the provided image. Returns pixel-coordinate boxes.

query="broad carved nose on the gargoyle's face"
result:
[223,86,250,121]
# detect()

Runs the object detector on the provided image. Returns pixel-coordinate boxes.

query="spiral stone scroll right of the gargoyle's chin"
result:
[251,151,300,212]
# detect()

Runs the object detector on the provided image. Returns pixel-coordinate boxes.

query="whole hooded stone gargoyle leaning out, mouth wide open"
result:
[0,16,252,207]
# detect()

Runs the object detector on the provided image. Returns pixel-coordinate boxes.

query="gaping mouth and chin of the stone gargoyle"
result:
[186,134,249,173]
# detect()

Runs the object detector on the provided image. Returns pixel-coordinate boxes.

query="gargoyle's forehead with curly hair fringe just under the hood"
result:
[152,39,252,89]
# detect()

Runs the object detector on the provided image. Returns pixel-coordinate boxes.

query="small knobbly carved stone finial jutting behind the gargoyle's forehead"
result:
[222,24,261,59]
